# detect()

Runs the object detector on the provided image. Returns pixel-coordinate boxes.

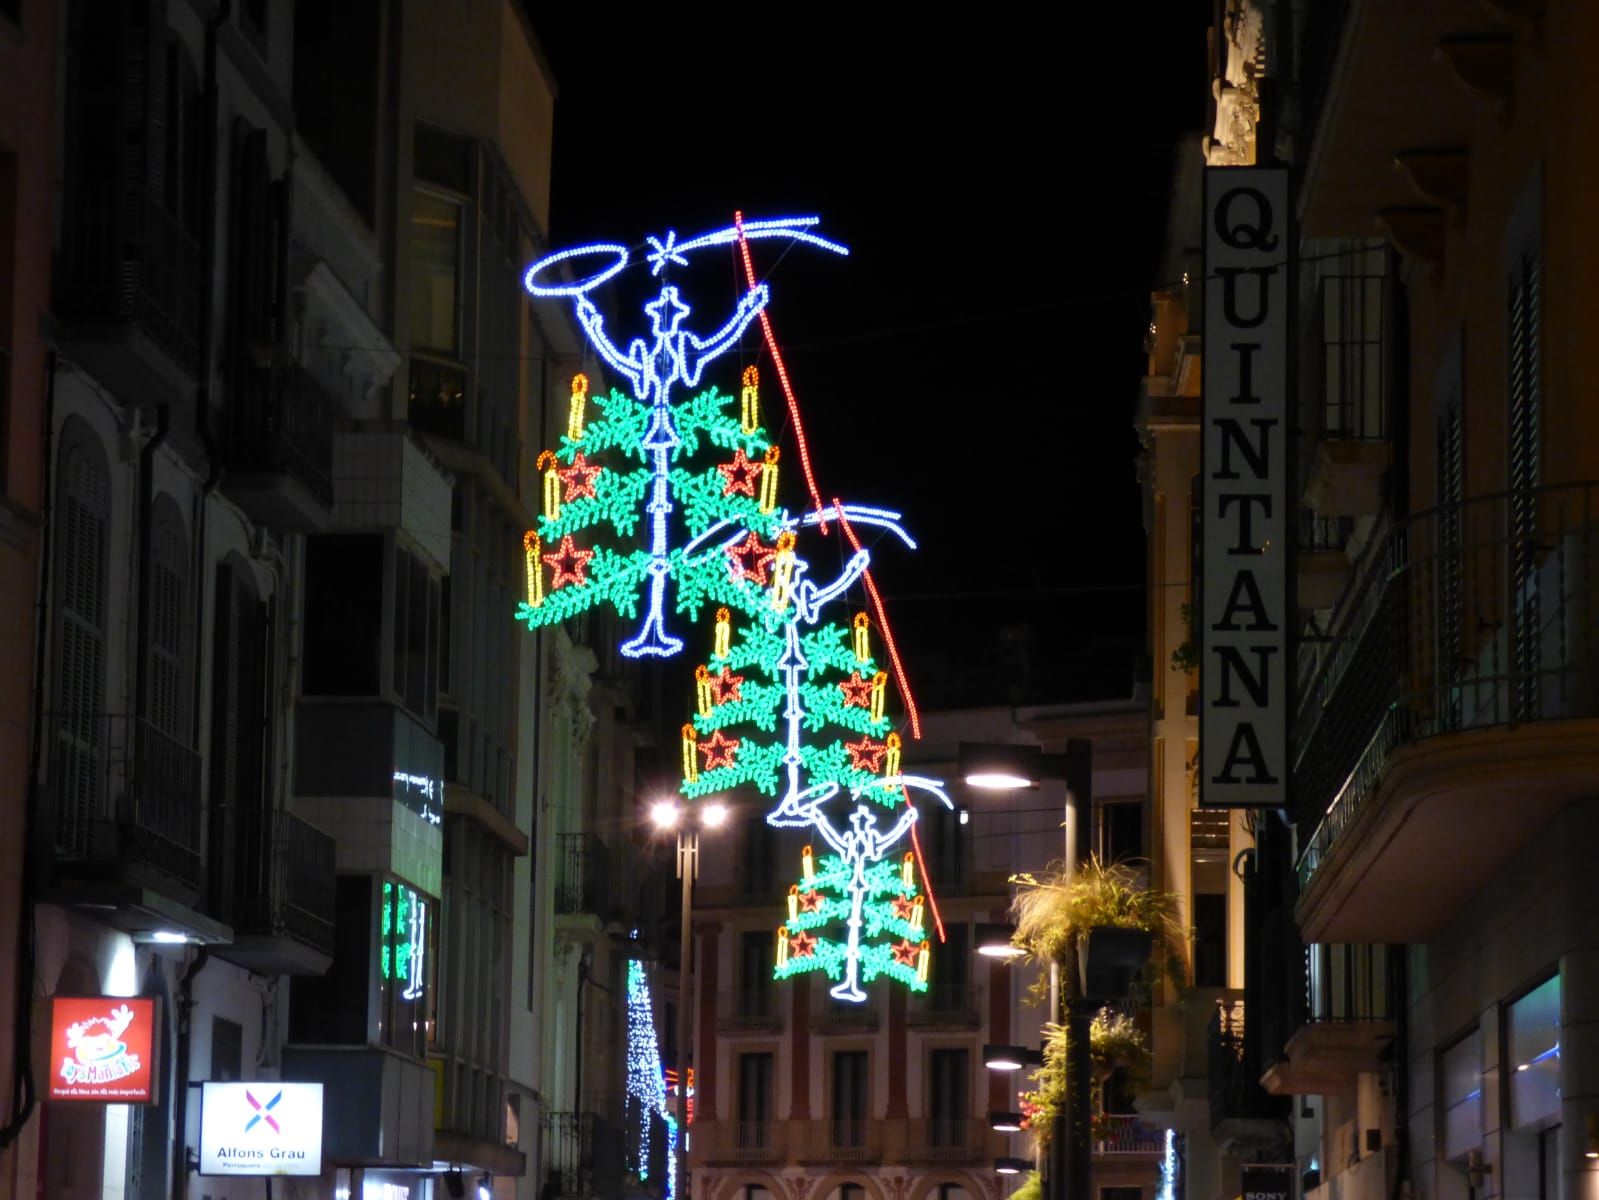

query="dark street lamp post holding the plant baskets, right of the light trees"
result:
[959,738,1094,1200]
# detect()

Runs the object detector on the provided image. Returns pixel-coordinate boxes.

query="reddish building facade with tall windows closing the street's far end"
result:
[689,702,1164,1200]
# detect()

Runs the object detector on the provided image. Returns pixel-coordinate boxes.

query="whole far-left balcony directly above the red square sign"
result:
[43,712,227,942]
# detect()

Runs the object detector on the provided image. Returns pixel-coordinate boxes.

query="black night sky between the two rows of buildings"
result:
[529,0,1210,707]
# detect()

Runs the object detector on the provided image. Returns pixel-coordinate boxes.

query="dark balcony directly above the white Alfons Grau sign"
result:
[211,808,336,974]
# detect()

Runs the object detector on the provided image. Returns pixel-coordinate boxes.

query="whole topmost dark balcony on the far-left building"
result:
[54,180,200,387]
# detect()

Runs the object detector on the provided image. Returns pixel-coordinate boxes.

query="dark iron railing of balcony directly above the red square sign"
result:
[46,712,201,893]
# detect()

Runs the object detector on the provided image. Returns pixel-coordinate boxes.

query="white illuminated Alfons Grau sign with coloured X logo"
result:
[200,1080,321,1174]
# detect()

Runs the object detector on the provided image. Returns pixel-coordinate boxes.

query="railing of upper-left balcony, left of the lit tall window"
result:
[227,360,334,504]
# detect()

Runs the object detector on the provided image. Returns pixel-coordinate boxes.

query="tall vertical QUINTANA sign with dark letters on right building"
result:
[1199,166,1294,808]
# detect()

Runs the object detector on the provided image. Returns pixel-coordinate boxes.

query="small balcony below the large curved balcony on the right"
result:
[1260,944,1394,1096]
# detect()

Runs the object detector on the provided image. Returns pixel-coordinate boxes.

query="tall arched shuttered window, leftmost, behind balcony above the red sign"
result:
[51,424,110,854]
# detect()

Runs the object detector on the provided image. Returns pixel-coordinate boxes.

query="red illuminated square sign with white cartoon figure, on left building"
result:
[50,995,157,1104]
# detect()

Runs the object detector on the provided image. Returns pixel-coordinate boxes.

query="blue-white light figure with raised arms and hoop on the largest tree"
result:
[524,218,849,658]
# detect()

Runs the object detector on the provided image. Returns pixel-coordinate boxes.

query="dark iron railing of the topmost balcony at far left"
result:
[54,180,200,371]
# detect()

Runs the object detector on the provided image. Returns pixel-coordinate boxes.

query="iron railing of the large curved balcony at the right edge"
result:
[1294,483,1599,891]
